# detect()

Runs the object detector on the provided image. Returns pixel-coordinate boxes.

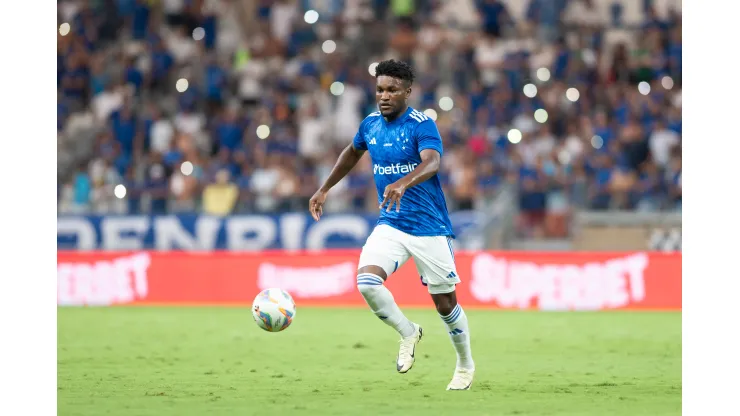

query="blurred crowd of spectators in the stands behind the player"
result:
[57,0,682,236]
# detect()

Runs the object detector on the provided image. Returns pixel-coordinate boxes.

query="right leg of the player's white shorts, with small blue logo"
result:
[408,236,460,294]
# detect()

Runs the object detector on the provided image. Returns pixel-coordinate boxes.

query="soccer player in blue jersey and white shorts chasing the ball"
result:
[309,60,475,390]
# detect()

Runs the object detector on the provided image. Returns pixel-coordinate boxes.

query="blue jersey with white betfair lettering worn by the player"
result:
[353,107,455,238]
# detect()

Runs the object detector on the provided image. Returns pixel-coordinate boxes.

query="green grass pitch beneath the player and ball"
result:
[57,305,681,416]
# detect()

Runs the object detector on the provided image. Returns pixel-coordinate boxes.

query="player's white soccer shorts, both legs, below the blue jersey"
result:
[358,224,460,294]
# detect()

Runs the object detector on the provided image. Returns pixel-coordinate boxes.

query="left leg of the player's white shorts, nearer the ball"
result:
[357,224,410,277]
